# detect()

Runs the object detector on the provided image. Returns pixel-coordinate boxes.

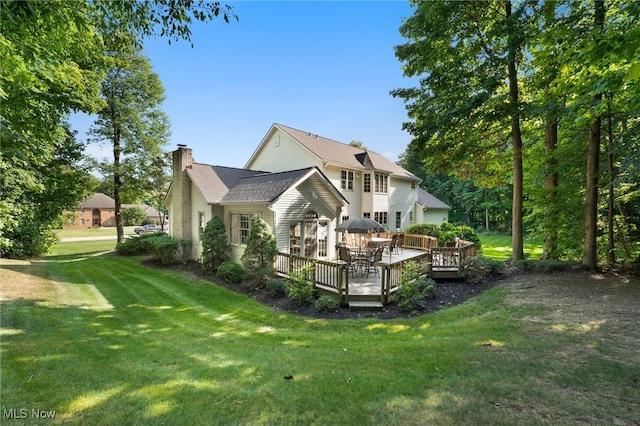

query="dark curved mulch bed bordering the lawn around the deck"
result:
[143,260,496,319]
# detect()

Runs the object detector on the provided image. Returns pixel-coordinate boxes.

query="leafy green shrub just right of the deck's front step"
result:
[395,261,436,312]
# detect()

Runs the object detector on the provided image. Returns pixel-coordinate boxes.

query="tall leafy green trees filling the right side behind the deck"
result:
[392,0,640,268]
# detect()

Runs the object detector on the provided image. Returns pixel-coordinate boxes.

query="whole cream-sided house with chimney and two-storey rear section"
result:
[166,124,449,260]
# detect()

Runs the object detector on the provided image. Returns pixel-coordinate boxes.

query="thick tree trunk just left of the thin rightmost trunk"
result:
[582,0,604,270]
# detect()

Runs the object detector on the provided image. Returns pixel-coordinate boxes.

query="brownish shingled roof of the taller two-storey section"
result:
[247,123,420,182]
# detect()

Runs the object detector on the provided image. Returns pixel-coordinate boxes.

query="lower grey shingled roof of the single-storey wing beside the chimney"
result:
[187,163,347,204]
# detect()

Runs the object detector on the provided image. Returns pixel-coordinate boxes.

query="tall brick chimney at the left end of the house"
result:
[169,144,193,239]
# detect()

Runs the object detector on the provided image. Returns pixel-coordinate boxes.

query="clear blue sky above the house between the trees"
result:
[72,1,415,167]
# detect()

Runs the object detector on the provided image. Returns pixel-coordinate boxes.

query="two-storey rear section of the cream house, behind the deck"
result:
[245,124,449,231]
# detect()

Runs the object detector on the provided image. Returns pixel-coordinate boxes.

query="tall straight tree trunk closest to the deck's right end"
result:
[505,1,524,262]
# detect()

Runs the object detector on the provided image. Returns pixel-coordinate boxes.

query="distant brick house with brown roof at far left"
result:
[64,192,160,229]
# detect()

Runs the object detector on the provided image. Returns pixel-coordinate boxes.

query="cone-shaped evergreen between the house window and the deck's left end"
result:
[242,216,278,285]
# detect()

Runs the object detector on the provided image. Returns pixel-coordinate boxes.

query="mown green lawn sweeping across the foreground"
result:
[0,241,640,425]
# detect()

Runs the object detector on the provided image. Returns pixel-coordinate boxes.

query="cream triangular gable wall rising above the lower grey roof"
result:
[247,129,322,172]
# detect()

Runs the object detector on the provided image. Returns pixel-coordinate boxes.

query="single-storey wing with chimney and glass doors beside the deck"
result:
[166,145,348,261]
